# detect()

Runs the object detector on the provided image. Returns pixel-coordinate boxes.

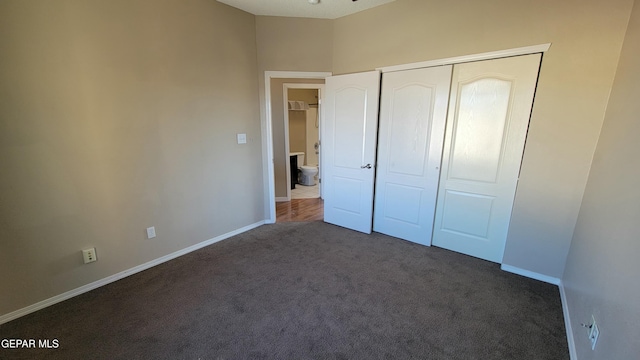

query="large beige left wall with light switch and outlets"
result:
[0,0,264,315]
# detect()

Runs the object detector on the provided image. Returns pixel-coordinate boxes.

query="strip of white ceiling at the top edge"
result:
[218,0,395,19]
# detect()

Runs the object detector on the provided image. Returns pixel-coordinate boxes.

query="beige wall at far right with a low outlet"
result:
[563,1,640,360]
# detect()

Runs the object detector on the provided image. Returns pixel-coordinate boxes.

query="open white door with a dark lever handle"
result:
[322,71,380,234]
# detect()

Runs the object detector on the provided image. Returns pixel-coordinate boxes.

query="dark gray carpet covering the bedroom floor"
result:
[0,222,569,360]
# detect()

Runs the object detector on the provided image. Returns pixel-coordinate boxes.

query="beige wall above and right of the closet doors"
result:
[333,0,633,278]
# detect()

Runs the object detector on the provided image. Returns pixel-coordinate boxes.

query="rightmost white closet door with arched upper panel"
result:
[433,54,541,262]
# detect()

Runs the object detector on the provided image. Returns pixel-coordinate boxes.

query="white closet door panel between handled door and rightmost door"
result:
[373,65,452,245]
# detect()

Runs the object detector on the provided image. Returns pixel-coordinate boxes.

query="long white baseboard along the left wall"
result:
[0,221,265,325]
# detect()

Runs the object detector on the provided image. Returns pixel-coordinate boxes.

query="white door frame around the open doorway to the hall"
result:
[260,71,332,224]
